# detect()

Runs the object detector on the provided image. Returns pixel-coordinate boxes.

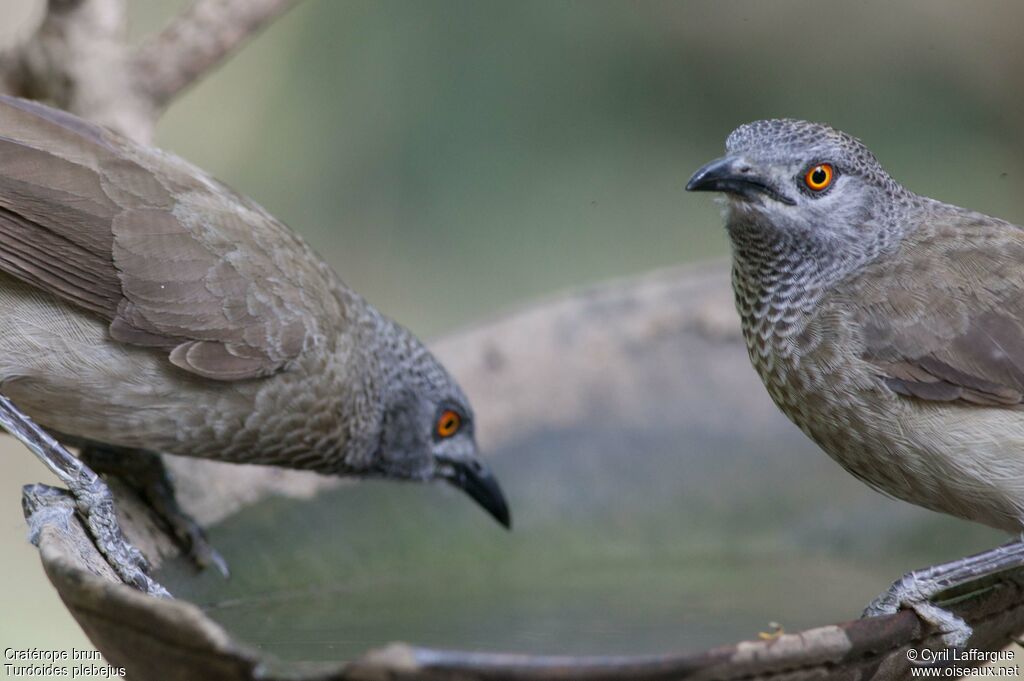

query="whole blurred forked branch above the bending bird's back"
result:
[0,0,297,142]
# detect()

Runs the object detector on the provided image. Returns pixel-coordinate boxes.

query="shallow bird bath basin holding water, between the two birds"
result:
[27,262,1024,681]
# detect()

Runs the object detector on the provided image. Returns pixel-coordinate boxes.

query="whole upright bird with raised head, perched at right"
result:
[686,120,1024,645]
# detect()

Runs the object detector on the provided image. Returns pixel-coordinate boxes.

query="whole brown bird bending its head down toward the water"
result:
[0,96,510,594]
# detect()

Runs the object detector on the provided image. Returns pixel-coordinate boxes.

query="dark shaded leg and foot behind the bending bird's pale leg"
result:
[81,444,230,578]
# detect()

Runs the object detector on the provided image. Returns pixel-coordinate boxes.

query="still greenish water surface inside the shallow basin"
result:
[159,421,1001,661]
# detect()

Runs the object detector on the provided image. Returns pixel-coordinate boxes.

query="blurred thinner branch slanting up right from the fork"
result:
[133,0,297,109]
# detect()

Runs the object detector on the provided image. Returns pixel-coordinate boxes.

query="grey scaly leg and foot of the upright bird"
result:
[863,540,1024,648]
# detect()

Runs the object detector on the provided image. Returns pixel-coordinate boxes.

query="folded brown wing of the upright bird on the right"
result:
[848,213,1024,407]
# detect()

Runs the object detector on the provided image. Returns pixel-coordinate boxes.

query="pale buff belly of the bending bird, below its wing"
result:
[0,274,266,458]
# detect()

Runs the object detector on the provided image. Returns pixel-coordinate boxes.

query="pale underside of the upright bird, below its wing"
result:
[752,339,1024,531]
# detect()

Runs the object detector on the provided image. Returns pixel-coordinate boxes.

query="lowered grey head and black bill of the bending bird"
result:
[368,325,511,527]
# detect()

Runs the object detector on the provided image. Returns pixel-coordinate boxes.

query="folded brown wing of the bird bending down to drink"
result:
[0,96,341,380]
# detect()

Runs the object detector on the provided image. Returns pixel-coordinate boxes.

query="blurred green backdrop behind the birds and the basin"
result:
[0,0,1024,667]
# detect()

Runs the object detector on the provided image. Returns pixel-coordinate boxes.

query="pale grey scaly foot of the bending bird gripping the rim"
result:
[22,477,171,598]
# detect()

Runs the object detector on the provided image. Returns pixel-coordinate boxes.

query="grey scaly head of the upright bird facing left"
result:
[686,119,912,274]
